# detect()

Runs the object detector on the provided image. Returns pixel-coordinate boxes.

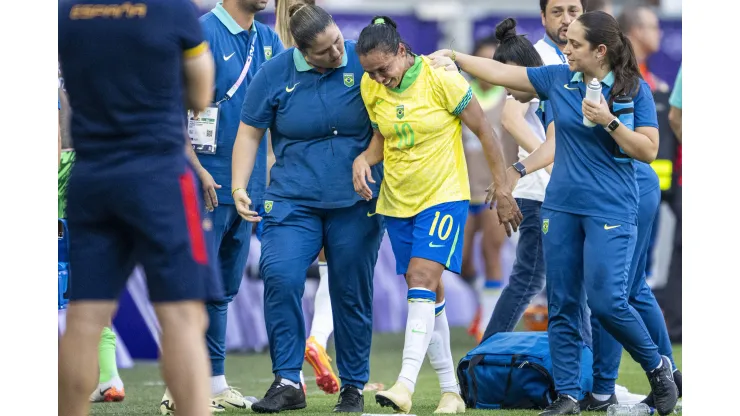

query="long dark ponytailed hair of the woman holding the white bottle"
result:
[577,11,642,97]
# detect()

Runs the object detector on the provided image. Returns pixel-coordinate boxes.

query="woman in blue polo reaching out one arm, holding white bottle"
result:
[434,12,678,416]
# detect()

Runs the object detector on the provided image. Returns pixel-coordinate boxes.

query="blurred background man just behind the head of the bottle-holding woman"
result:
[617,5,669,92]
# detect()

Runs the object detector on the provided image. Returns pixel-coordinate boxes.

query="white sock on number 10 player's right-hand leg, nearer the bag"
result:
[427,300,460,394]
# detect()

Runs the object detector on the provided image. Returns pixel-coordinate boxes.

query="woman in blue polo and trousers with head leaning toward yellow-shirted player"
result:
[231,4,383,413]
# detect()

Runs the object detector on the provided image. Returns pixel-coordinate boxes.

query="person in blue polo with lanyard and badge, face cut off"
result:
[175,0,284,410]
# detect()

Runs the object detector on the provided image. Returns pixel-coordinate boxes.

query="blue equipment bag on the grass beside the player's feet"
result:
[457,332,593,409]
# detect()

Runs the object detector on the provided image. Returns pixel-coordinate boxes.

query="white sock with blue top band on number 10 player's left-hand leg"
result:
[398,287,437,393]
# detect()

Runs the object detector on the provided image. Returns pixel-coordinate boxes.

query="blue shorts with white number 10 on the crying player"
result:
[385,201,470,274]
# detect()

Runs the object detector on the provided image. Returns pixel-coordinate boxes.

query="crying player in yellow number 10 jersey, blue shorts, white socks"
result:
[353,17,522,413]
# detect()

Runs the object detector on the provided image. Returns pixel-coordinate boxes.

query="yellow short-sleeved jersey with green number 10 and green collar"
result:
[360,56,473,218]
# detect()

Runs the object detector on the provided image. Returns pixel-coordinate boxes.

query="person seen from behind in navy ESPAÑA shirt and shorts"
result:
[58,0,222,416]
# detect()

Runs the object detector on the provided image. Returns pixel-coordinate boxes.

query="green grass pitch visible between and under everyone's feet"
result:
[91,328,681,416]
